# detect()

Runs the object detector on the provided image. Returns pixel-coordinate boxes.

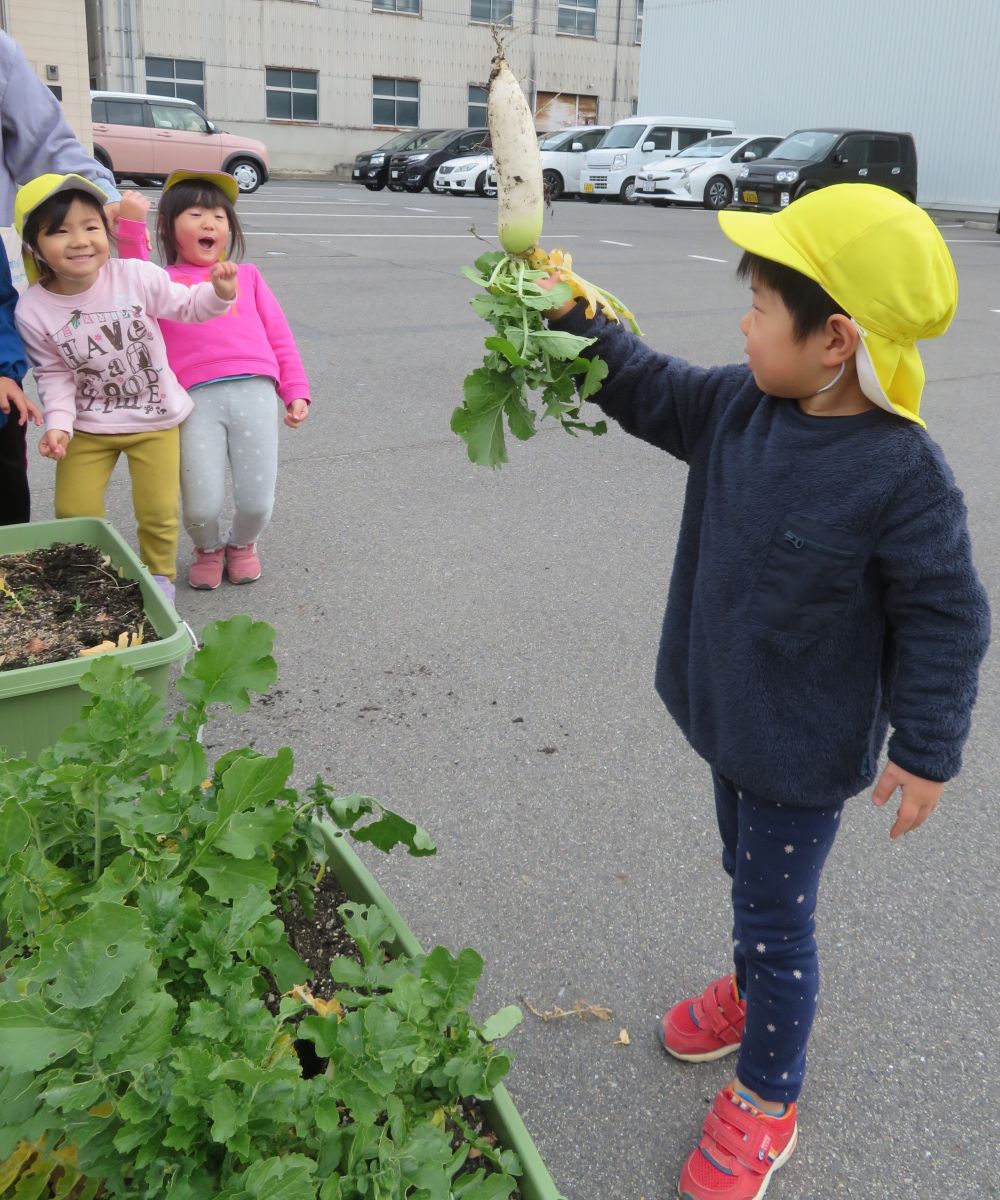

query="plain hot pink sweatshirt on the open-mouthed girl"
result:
[118,221,310,406]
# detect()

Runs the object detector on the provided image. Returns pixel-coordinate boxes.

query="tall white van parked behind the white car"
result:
[580,116,736,204]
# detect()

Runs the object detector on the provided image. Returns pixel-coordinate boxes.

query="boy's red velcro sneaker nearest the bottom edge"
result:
[677,1088,798,1200]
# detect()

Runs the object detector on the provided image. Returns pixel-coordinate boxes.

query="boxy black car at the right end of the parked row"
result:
[732,130,917,210]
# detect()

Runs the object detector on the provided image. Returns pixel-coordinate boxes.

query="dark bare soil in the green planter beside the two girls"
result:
[0,542,158,671]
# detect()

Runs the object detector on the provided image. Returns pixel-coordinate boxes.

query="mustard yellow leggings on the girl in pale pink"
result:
[55,426,180,580]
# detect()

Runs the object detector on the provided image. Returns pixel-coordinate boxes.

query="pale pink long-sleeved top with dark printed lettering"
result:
[14,258,229,433]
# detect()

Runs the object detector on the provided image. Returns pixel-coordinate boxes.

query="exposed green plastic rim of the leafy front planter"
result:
[317,821,565,1200]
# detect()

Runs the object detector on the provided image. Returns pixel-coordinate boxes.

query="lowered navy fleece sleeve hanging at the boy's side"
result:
[876,454,989,782]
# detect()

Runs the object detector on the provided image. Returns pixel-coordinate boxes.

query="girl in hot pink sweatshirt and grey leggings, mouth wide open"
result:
[119,170,310,589]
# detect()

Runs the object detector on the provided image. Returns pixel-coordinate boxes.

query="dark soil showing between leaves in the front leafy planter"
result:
[278,874,522,1200]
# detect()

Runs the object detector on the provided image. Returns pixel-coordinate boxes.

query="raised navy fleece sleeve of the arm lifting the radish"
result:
[550,301,745,462]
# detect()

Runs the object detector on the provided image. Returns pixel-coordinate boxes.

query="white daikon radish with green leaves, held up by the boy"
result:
[451,42,639,467]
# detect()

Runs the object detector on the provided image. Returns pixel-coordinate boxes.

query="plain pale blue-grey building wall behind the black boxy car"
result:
[639,0,1000,212]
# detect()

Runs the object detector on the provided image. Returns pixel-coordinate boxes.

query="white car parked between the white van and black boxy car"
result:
[635,133,782,209]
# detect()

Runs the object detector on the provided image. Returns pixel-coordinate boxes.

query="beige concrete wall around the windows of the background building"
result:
[86,0,639,172]
